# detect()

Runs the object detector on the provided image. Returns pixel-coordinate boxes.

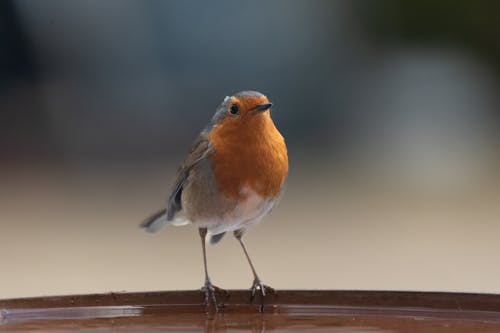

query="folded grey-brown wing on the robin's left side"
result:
[167,134,210,221]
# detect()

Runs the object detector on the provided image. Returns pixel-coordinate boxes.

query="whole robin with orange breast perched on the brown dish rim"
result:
[141,91,288,310]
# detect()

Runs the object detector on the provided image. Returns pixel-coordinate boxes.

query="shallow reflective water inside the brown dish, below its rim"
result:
[0,305,500,333]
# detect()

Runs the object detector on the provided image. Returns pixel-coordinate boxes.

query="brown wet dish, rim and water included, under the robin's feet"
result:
[0,291,500,333]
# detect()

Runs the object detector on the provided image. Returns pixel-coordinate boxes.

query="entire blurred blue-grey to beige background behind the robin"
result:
[0,0,500,298]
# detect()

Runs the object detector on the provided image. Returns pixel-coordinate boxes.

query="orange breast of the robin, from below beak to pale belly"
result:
[208,112,288,198]
